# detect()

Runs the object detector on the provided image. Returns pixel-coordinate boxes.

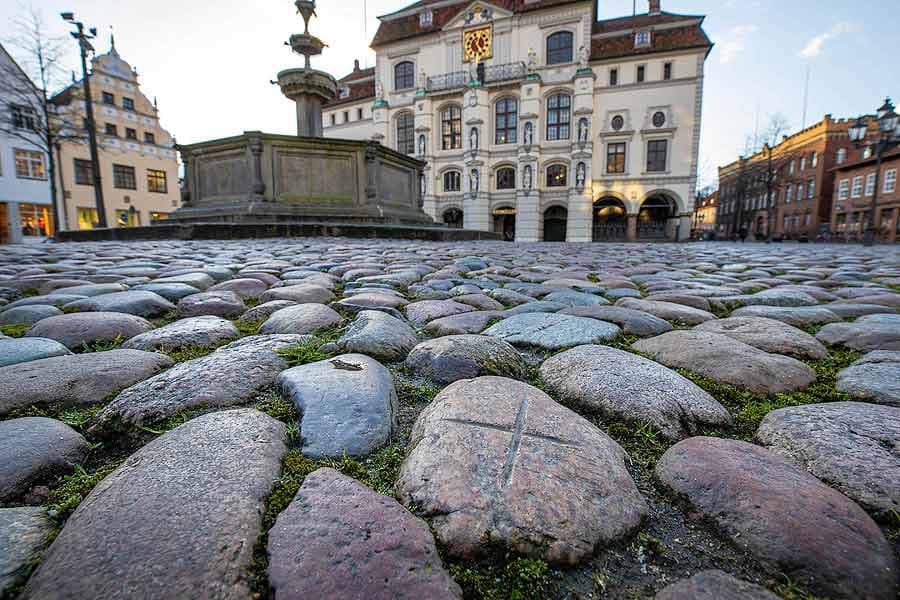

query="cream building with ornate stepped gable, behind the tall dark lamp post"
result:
[51,40,181,229]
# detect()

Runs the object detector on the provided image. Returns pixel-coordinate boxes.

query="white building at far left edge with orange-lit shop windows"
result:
[0,46,53,244]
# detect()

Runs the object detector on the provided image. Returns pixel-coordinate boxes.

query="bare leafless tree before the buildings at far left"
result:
[0,7,84,231]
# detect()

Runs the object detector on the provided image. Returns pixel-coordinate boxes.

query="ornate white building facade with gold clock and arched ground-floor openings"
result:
[323,0,712,242]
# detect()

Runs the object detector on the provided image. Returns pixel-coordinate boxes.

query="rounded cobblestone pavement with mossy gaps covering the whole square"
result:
[0,238,900,600]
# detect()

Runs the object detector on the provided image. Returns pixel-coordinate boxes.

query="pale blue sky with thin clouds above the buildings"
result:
[0,0,900,184]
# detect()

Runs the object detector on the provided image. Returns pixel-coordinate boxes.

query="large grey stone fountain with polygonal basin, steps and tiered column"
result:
[59,0,497,240]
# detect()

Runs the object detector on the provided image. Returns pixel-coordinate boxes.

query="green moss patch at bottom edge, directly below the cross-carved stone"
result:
[449,557,552,600]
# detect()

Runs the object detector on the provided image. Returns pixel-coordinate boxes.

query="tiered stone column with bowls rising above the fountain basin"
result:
[278,0,337,137]
